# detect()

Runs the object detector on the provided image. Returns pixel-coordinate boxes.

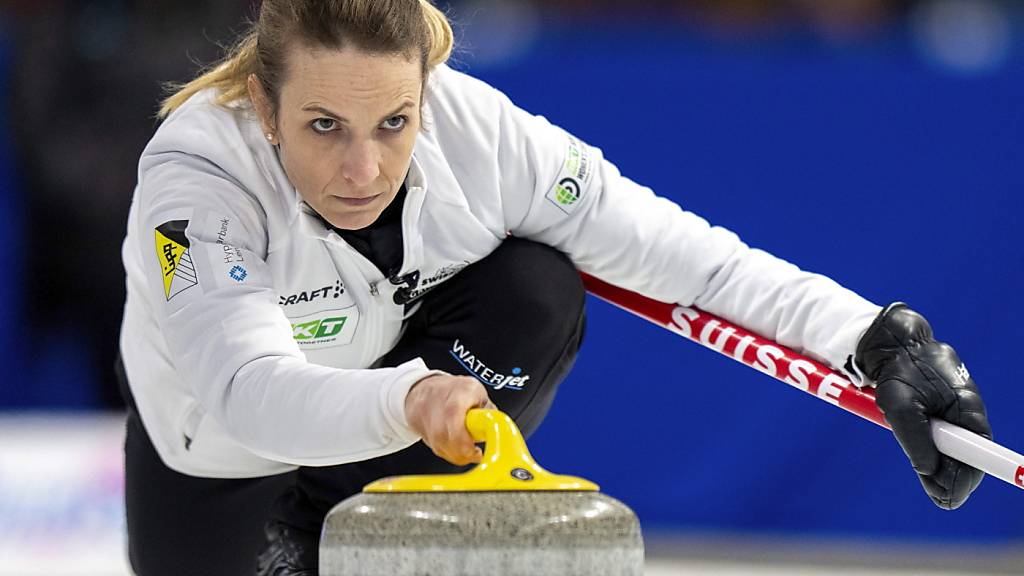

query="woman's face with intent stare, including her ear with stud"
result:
[250,45,423,230]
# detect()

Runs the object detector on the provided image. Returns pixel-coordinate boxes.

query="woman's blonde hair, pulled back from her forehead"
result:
[158,0,455,118]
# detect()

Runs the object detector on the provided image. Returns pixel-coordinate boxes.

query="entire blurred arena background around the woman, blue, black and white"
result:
[0,0,1024,575]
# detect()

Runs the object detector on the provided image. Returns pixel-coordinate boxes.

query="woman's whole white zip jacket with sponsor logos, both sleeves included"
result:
[121,61,879,478]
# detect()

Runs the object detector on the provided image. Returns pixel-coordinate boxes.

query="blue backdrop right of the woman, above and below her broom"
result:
[469,26,1024,543]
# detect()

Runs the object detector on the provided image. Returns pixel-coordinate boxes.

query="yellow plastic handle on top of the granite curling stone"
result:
[362,409,599,492]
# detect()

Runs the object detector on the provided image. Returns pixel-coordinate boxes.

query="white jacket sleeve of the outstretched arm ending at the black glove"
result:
[498,89,881,369]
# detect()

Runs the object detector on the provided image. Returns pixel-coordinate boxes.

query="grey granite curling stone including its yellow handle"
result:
[319,410,643,576]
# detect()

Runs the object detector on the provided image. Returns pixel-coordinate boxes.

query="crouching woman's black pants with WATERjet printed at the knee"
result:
[122,239,585,576]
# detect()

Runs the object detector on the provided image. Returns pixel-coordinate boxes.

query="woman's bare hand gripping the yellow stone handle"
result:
[406,374,496,466]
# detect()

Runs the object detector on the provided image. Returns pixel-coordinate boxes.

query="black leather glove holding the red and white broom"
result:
[855,302,992,509]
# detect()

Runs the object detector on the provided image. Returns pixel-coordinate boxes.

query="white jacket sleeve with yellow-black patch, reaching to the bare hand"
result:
[135,153,432,465]
